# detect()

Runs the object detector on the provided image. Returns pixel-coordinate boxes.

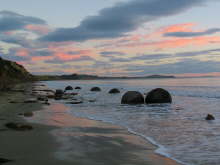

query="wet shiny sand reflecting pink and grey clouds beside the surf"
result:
[29,103,179,165]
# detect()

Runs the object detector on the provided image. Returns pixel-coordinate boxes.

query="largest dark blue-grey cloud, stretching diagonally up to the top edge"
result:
[41,0,207,42]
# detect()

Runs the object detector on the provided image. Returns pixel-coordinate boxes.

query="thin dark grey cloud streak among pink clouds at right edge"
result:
[164,28,220,37]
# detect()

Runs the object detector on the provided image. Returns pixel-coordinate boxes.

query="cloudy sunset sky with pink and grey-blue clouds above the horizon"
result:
[0,0,220,76]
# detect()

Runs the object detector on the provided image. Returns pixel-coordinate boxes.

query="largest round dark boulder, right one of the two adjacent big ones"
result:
[145,88,172,104]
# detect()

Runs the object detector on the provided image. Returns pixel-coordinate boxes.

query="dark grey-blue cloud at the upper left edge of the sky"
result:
[0,11,46,32]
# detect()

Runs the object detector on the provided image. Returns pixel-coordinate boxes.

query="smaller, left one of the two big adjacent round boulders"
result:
[121,91,144,104]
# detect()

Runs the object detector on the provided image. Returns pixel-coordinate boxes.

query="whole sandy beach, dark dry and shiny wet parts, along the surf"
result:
[0,83,178,165]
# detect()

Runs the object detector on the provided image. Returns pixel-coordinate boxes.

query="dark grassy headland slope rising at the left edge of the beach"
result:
[0,57,33,90]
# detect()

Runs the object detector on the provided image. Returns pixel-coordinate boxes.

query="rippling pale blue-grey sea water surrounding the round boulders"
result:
[45,78,220,165]
